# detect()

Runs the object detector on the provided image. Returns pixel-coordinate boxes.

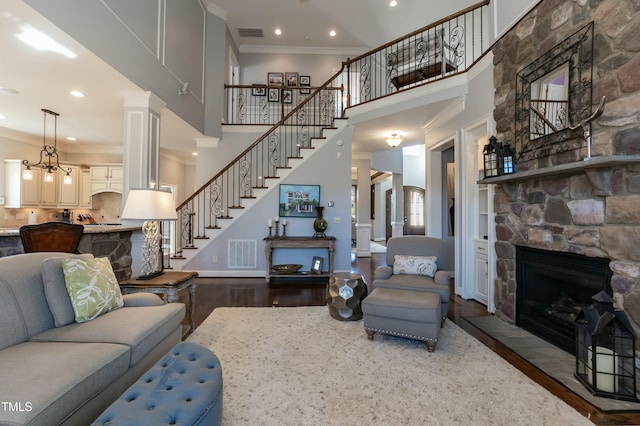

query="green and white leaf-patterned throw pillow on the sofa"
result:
[62,257,124,322]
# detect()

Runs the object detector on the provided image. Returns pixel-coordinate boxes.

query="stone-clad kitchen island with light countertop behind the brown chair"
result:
[0,225,141,282]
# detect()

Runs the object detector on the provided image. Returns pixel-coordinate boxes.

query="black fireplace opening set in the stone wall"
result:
[516,246,613,355]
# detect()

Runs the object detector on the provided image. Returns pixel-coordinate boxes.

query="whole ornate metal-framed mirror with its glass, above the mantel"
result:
[514,22,593,170]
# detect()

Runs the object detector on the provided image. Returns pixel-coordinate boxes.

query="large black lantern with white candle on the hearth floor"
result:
[575,291,639,402]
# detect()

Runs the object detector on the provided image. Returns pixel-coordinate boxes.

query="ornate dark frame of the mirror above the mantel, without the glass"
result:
[515,22,593,170]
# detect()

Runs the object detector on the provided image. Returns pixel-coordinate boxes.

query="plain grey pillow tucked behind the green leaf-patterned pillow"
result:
[42,254,93,327]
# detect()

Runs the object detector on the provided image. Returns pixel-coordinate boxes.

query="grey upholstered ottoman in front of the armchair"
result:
[362,287,441,352]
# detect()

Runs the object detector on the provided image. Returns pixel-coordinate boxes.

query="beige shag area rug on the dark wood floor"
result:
[188,306,592,426]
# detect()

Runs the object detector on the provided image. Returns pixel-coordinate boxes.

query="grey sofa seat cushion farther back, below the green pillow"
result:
[31,303,185,366]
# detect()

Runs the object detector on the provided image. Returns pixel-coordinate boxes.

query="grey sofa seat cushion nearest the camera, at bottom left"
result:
[0,342,129,426]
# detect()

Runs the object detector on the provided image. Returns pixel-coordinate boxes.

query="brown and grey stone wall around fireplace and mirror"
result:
[493,0,640,340]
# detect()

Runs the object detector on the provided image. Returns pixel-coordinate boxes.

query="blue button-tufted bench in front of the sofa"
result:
[93,342,222,426]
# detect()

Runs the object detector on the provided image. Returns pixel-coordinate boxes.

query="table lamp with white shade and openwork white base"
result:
[122,188,178,280]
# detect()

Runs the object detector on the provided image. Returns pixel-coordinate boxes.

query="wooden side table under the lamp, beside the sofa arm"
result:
[120,271,198,338]
